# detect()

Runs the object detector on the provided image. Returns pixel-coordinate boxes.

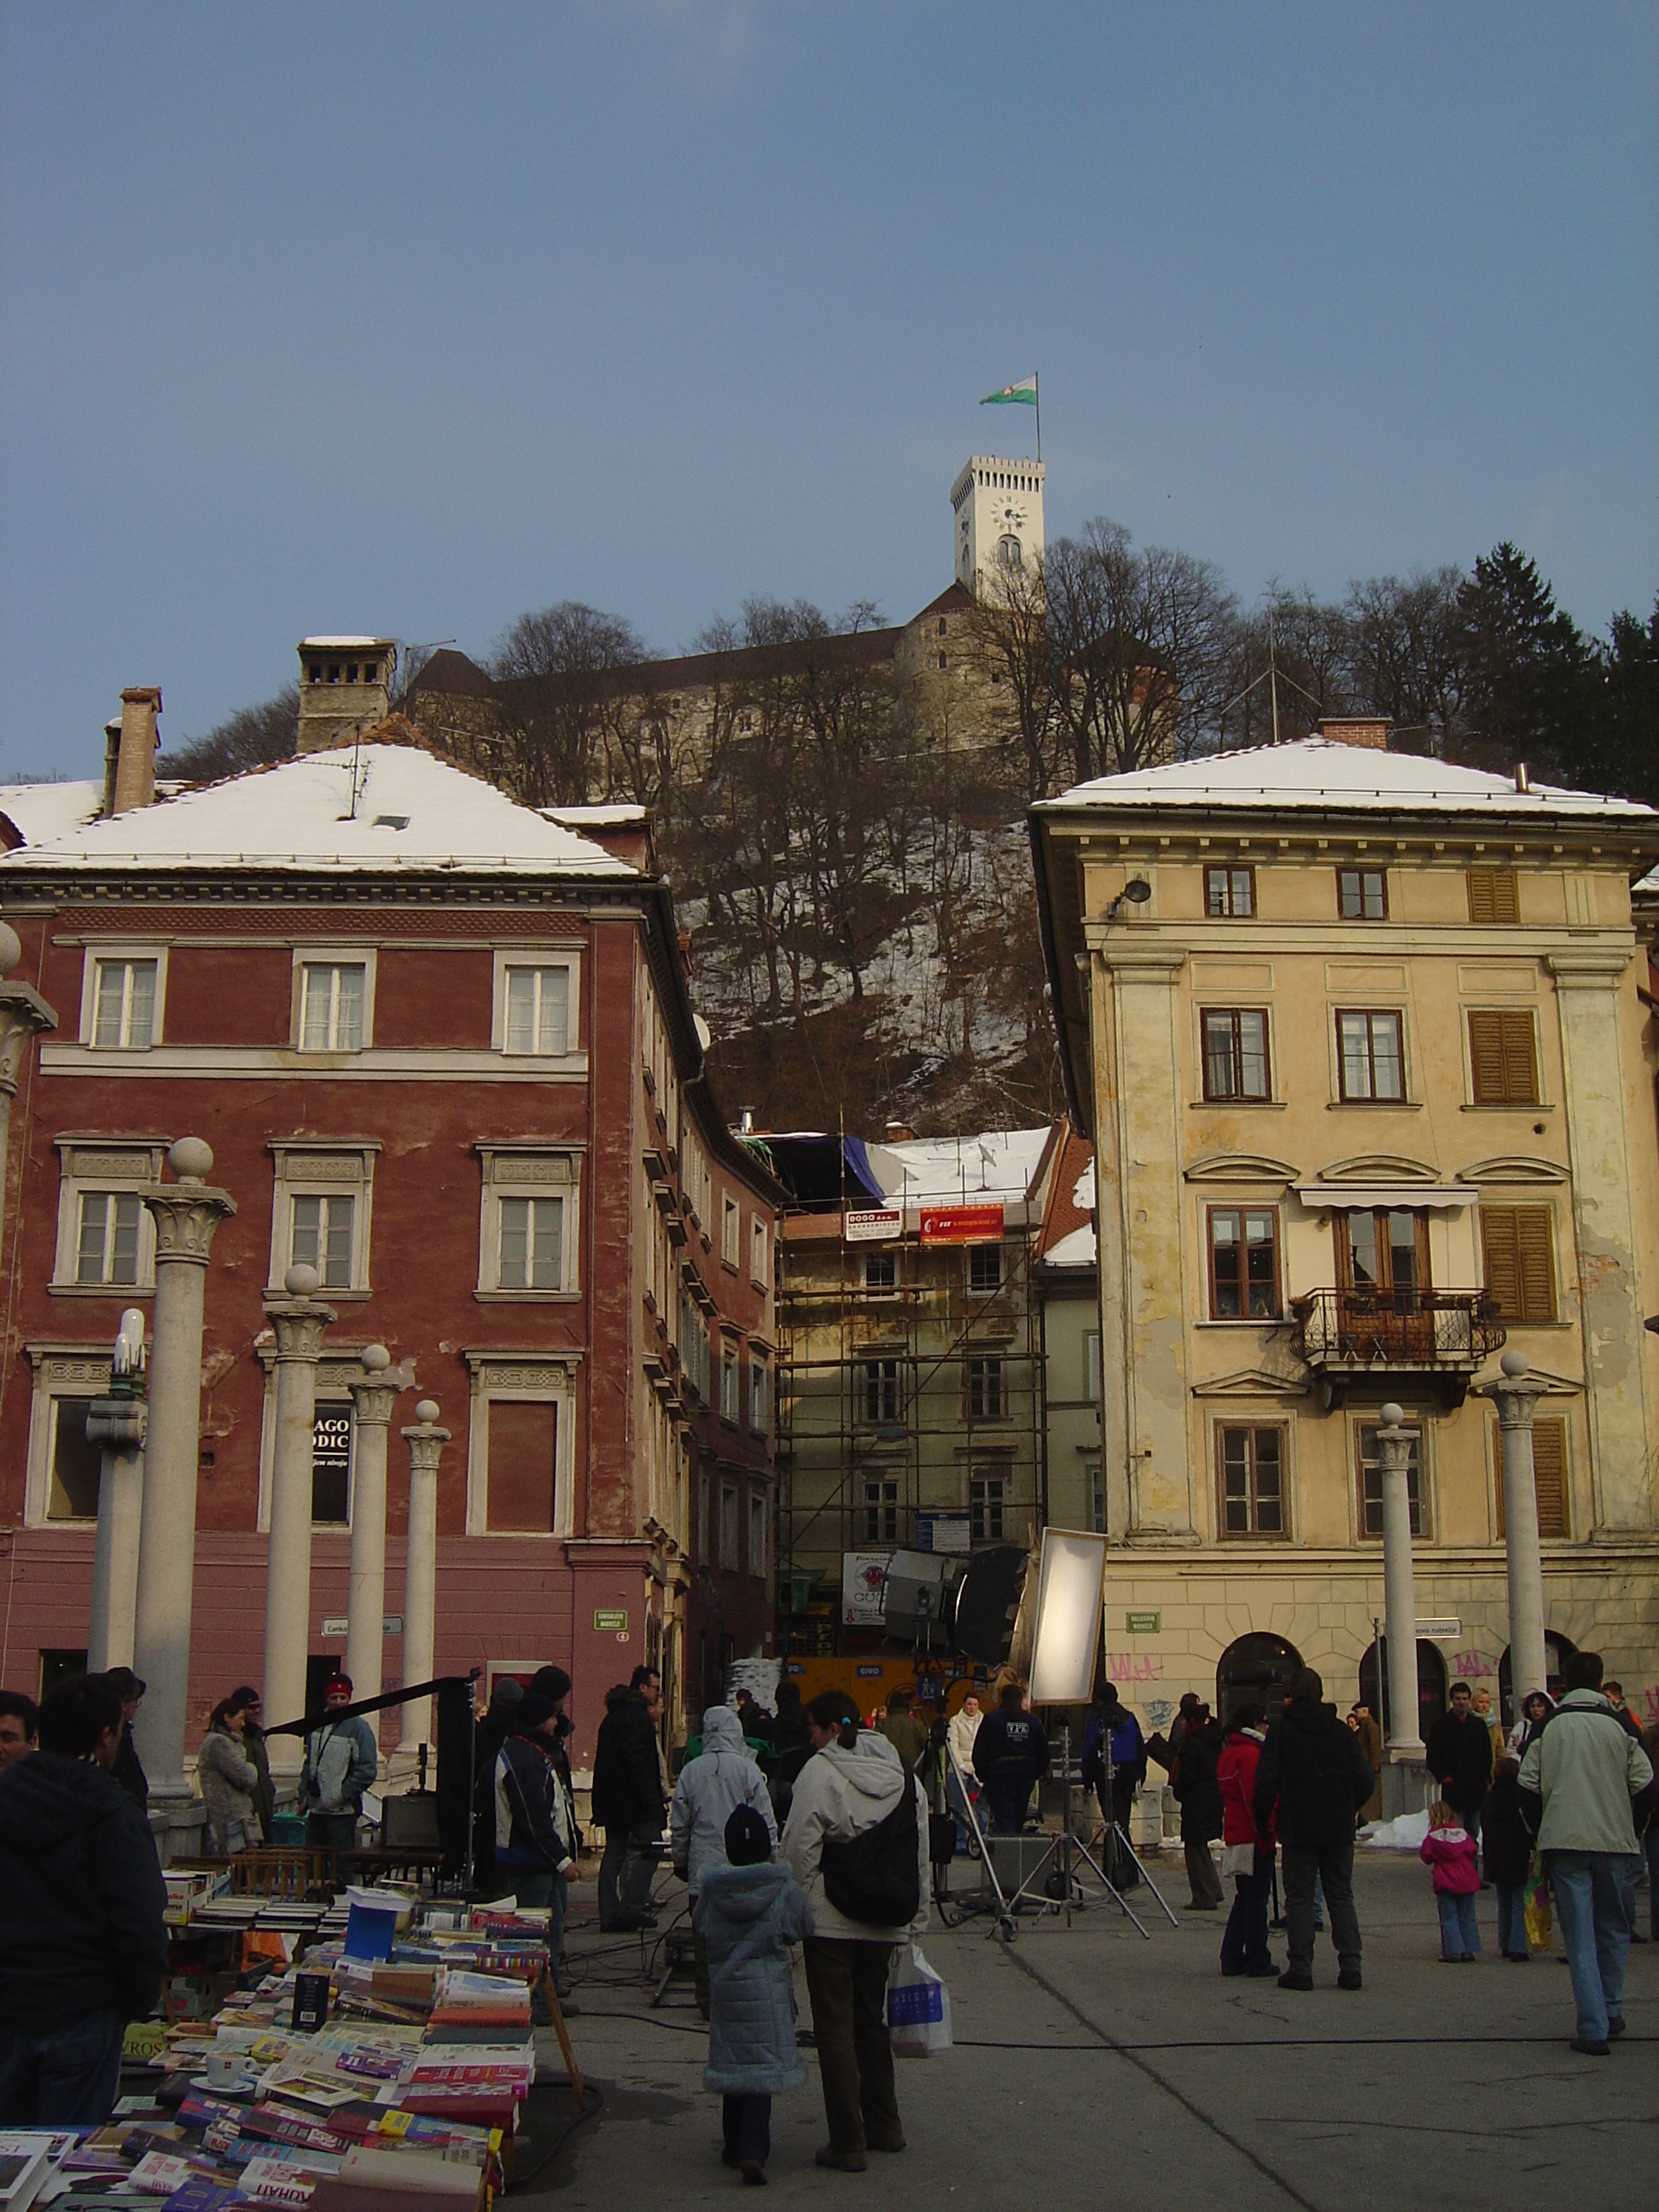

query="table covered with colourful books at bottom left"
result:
[0,1891,586,2212]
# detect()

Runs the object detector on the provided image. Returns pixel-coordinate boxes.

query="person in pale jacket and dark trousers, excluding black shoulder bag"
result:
[783,1692,927,2172]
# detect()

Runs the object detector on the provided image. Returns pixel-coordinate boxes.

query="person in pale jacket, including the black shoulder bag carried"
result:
[783,1690,927,2174]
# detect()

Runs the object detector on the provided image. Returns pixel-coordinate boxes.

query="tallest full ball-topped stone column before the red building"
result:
[133,1137,236,1813]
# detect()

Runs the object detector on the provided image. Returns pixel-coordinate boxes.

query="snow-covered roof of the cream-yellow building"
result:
[1033,736,1659,825]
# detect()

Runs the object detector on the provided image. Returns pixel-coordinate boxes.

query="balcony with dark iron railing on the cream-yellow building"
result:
[1289,1289,1505,1409]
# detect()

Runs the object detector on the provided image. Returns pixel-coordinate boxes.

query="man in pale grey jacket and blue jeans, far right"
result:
[1520,1652,1652,2059]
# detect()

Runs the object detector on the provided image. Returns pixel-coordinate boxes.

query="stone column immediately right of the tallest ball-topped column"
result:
[261,1263,336,1778]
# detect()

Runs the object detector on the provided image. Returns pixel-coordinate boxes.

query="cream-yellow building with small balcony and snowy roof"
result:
[1033,724,1659,1716]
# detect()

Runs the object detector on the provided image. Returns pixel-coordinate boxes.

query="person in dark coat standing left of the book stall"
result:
[0,1674,168,2128]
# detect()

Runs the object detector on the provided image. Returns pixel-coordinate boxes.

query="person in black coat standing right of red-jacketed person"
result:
[1252,1666,1380,1988]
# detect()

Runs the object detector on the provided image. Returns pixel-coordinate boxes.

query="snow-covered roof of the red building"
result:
[0,743,639,878]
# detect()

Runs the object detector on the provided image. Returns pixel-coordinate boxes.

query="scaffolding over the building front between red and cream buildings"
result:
[777,1199,1046,1656]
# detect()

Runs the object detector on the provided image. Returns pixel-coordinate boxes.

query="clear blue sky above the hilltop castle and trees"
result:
[0,0,1659,777]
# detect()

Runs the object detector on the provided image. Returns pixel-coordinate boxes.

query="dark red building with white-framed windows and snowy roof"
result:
[0,707,778,1765]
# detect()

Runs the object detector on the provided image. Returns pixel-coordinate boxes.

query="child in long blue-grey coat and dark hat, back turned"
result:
[692,1805,812,2183]
